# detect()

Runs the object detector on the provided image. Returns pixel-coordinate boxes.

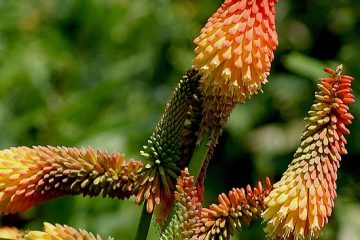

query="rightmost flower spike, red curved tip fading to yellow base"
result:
[263,65,354,240]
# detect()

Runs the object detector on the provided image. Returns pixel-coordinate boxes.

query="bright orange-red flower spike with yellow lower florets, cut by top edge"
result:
[193,0,278,102]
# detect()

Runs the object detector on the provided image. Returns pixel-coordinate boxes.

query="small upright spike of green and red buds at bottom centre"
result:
[160,169,201,240]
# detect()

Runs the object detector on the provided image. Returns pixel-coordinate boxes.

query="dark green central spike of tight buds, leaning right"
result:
[135,69,199,218]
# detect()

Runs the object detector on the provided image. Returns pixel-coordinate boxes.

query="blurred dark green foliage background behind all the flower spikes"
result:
[0,0,360,240]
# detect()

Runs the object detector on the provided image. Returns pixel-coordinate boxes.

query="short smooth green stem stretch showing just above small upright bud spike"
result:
[189,133,210,183]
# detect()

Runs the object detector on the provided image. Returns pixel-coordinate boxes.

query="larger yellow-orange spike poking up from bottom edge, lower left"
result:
[19,223,106,240]
